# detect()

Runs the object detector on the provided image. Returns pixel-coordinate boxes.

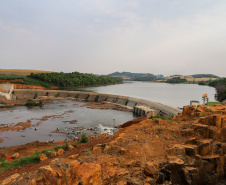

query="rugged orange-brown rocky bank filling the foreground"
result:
[1,105,226,185]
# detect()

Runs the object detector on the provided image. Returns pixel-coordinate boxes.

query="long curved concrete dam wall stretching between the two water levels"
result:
[13,89,181,115]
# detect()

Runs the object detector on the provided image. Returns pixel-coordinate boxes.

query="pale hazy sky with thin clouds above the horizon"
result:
[0,0,226,77]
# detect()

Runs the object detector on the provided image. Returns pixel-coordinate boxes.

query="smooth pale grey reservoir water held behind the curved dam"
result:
[76,81,216,107]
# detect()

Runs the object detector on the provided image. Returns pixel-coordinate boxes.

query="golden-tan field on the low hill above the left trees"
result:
[0,69,53,76]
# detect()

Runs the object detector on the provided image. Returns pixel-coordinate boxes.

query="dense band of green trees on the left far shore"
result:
[0,72,122,87]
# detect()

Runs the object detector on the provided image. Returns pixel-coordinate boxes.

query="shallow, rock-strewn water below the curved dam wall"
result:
[0,100,134,147]
